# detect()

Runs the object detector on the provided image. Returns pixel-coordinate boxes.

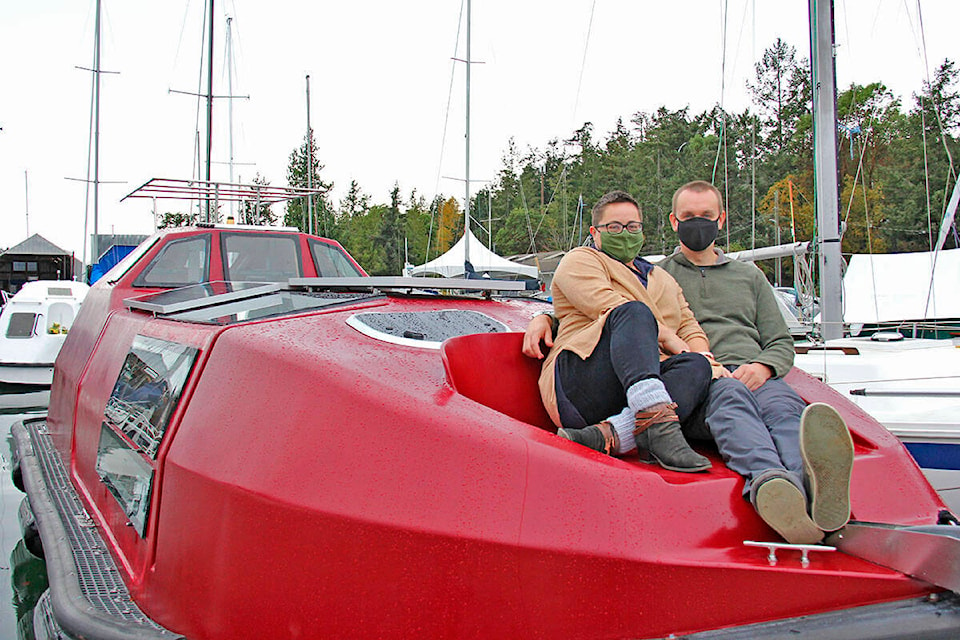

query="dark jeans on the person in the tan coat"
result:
[556,302,711,429]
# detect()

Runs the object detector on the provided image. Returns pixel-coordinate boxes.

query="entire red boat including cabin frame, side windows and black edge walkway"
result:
[15,231,960,640]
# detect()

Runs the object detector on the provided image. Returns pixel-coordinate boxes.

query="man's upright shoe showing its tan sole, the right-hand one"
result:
[800,403,853,531]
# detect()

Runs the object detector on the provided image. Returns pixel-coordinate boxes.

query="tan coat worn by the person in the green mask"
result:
[540,247,719,426]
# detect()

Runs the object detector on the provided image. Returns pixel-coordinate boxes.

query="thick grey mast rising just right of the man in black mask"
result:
[809,0,843,340]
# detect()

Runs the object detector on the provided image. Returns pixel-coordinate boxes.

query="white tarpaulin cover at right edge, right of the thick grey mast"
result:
[843,249,960,324]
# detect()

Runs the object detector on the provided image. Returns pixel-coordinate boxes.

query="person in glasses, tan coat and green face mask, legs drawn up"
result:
[540,191,723,472]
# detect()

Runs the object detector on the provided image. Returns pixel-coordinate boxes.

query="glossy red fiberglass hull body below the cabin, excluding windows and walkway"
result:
[35,282,943,640]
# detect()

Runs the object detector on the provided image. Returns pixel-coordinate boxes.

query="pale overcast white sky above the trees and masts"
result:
[0,0,960,257]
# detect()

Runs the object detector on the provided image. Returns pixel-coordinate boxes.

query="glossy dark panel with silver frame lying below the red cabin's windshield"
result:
[124,282,371,325]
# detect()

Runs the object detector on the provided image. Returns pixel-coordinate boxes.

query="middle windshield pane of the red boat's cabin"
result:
[220,233,303,282]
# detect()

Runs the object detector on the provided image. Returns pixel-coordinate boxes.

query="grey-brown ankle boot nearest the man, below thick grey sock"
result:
[633,402,711,473]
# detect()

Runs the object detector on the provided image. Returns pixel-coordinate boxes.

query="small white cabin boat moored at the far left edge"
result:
[0,280,90,387]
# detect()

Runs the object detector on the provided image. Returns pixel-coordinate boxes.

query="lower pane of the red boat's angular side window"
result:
[97,422,153,538]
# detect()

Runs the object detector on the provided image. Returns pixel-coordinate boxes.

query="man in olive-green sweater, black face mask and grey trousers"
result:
[524,181,853,543]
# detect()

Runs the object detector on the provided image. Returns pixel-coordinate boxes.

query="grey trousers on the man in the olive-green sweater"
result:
[684,378,807,504]
